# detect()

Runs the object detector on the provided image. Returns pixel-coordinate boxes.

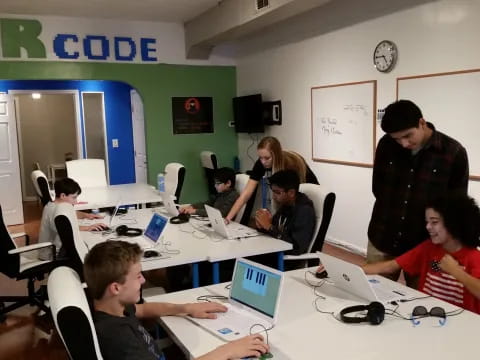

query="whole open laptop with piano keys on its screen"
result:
[188,258,284,341]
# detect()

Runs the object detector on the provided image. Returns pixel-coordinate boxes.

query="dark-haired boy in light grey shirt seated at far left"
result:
[38,178,107,260]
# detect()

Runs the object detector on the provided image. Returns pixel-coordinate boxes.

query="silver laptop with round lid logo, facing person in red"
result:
[317,253,413,304]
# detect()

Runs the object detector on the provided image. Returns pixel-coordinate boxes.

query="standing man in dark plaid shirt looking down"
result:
[367,100,468,286]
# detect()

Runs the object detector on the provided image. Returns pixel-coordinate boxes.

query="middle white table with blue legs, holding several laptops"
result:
[80,208,292,287]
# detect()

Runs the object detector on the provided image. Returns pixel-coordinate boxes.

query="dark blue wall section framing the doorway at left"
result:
[0,80,135,185]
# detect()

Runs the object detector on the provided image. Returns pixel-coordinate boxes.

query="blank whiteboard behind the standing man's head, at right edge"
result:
[397,69,480,179]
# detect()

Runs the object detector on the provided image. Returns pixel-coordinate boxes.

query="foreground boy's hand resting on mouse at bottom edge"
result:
[212,334,270,359]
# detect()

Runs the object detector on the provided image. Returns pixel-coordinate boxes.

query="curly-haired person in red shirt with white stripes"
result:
[363,194,480,314]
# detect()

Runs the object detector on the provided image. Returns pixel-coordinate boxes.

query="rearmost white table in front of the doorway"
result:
[75,184,162,210]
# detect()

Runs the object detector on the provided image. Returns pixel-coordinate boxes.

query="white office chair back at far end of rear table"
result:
[66,159,107,189]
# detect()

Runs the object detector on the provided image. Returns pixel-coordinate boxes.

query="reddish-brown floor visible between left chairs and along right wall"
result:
[0,203,365,360]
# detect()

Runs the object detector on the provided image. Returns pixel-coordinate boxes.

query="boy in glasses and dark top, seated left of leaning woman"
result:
[180,167,239,217]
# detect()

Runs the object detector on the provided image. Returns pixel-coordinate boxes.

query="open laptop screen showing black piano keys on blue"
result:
[230,260,282,319]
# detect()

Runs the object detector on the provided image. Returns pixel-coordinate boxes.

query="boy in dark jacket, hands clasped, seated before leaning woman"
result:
[255,170,315,255]
